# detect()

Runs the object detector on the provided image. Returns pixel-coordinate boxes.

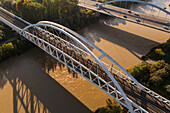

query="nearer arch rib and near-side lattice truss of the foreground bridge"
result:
[21,24,147,112]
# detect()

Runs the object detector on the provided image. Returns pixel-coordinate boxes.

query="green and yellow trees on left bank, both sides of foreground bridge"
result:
[0,0,98,61]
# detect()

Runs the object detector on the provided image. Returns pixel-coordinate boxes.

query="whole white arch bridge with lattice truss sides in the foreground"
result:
[0,8,170,113]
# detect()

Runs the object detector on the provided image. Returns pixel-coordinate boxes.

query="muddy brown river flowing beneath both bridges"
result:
[0,0,170,113]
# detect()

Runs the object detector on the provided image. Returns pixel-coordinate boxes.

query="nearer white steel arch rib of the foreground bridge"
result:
[20,22,147,113]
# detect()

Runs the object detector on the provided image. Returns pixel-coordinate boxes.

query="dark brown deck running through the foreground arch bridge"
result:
[0,7,170,113]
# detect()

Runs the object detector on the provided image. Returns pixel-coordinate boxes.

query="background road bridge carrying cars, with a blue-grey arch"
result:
[78,0,170,33]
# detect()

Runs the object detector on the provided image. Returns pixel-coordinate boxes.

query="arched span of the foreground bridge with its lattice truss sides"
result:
[0,7,170,113]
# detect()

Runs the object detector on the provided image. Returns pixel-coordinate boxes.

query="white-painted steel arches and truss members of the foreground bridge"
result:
[0,6,170,112]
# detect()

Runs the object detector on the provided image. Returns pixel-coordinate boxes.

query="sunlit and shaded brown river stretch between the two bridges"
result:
[78,17,169,69]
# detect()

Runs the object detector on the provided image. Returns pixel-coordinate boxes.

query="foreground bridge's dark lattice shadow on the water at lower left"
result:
[0,48,91,113]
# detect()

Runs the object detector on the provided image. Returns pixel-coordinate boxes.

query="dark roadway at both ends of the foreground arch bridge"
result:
[0,6,170,113]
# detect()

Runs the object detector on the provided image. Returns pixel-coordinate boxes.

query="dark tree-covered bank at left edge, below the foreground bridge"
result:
[0,24,33,63]
